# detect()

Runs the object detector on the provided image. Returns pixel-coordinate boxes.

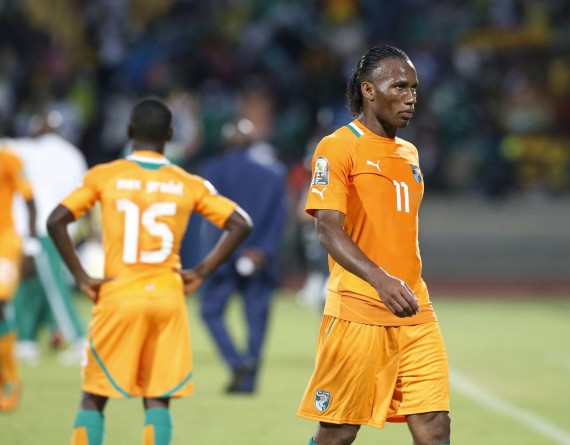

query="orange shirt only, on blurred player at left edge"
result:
[0,148,32,234]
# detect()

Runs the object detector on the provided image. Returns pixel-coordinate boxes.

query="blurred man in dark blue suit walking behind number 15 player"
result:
[200,119,287,393]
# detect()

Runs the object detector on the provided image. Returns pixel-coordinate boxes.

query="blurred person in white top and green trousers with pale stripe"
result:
[8,111,87,364]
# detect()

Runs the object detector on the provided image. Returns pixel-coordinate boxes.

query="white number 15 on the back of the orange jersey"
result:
[117,199,176,264]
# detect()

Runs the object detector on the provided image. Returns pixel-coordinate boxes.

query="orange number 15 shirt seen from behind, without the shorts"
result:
[62,151,237,299]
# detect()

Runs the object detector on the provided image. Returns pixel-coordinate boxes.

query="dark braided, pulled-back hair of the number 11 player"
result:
[346,45,410,118]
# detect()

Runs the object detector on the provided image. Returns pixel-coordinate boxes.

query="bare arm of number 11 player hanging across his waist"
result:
[315,210,420,317]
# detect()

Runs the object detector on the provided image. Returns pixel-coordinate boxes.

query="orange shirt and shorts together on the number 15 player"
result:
[57,151,237,397]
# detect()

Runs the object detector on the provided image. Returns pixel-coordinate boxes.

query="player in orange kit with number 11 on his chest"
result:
[298,45,450,445]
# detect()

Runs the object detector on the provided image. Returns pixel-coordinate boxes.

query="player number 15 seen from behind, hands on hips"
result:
[47,98,251,445]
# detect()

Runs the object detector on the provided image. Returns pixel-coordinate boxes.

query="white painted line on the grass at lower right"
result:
[450,370,570,445]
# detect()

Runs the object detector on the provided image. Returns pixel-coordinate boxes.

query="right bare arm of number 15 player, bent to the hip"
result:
[175,208,253,295]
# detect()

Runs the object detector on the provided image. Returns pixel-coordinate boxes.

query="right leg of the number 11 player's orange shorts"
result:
[390,322,449,421]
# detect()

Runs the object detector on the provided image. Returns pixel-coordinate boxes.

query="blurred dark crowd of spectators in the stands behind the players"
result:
[0,0,570,197]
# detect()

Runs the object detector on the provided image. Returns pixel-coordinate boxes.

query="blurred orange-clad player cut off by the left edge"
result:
[0,147,36,411]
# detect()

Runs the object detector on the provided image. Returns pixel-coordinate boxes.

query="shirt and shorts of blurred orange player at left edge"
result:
[0,149,32,299]
